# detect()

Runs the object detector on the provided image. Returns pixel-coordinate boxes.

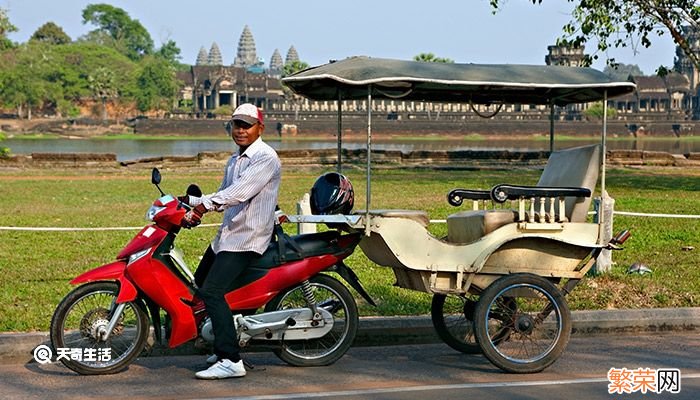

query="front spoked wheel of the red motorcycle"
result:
[51,282,148,375]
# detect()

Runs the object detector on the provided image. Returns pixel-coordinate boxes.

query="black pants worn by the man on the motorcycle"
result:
[194,246,259,362]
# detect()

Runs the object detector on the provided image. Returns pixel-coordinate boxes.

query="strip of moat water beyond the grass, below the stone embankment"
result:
[0,138,700,161]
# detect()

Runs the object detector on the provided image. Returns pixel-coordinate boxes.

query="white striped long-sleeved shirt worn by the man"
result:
[190,138,282,254]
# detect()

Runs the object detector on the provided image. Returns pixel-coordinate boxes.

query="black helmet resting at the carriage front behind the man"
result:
[311,172,355,215]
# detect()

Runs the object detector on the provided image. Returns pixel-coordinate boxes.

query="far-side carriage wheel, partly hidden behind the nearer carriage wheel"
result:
[430,294,481,354]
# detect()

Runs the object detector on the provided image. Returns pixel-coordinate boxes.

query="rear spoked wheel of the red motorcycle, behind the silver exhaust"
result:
[265,275,359,367]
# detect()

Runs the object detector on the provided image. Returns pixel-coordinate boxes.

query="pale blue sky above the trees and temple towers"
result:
[0,0,675,74]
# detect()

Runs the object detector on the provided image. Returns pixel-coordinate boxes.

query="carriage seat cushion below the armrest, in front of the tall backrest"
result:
[447,210,518,243]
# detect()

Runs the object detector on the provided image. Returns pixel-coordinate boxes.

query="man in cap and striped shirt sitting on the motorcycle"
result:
[185,104,281,379]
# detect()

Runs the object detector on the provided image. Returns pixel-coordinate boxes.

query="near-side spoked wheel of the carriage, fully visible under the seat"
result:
[474,274,571,373]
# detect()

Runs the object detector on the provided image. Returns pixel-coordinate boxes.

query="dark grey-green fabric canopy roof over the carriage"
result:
[282,56,635,106]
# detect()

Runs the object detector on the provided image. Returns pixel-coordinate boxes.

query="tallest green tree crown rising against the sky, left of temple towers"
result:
[83,4,153,60]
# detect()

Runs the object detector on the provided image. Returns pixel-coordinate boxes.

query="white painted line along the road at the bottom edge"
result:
[197,374,700,400]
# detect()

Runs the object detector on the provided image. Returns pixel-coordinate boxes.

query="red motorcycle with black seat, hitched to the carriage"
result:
[50,169,374,375]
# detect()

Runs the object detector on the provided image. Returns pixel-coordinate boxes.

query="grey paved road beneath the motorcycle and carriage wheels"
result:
[0,332,700,400]
